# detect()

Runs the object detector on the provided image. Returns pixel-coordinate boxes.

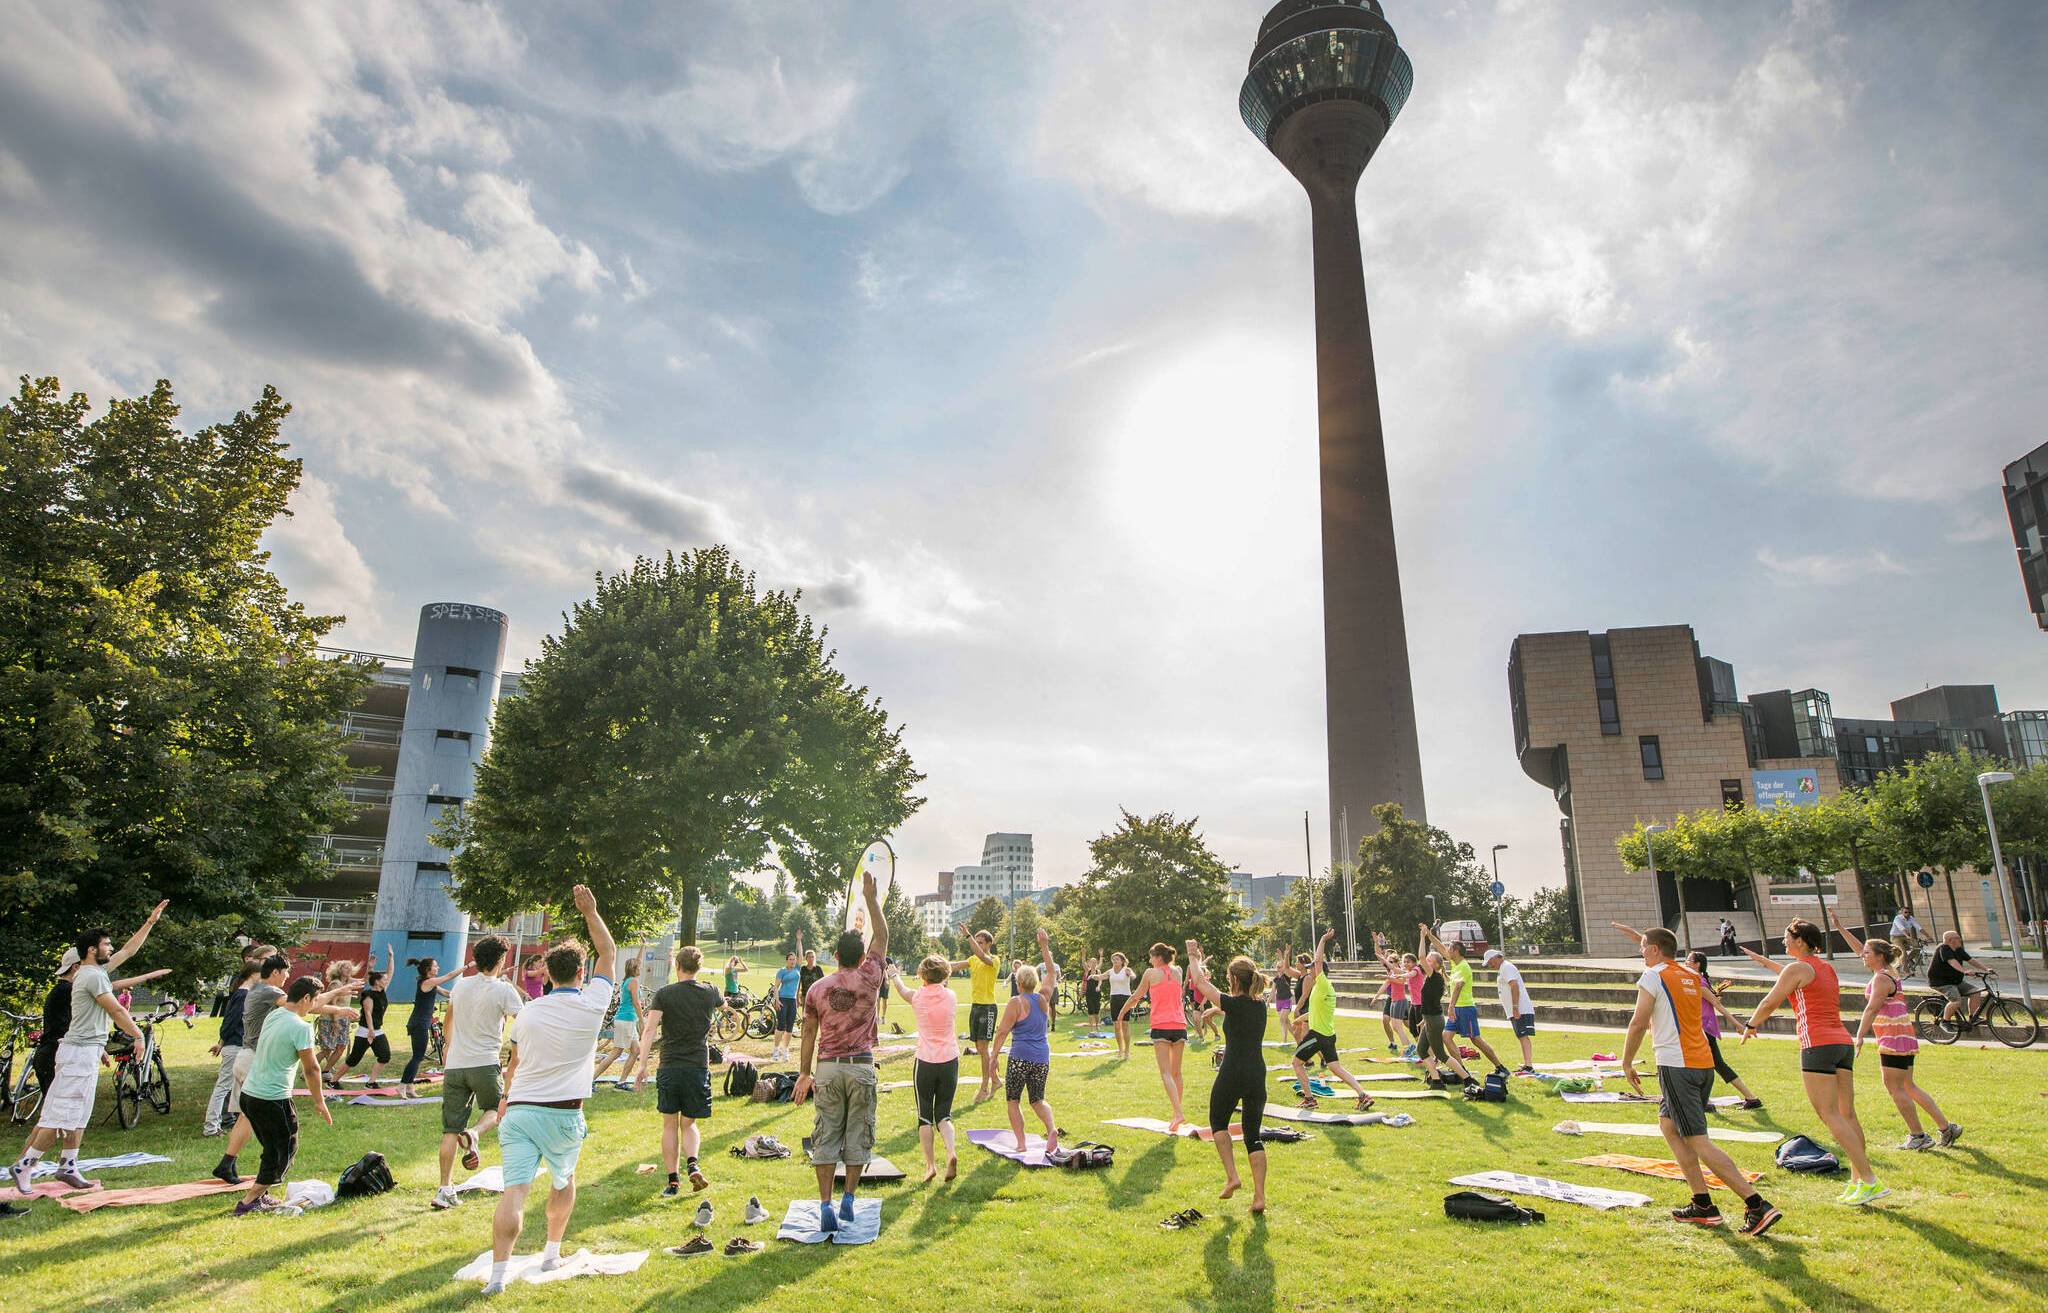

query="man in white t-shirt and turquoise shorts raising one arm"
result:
[483,885,618,1295]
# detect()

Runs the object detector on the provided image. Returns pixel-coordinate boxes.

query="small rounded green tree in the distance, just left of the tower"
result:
[1073,811,1251,963]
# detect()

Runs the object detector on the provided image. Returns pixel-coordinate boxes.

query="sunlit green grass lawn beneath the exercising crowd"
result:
[0,991,2048,1313]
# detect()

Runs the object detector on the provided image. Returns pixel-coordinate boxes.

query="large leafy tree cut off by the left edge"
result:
[0,377,369,993]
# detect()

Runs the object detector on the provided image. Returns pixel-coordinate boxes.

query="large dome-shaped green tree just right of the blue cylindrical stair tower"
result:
[453,547,924,942]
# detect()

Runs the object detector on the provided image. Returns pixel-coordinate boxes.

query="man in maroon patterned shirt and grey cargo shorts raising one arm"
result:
[793,871,889,1231]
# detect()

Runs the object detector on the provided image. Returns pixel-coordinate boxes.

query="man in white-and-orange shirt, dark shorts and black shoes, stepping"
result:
[1622,926,1780,1235]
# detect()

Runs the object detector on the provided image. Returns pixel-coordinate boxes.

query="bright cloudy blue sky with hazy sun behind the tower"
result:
[0,0,2048,893]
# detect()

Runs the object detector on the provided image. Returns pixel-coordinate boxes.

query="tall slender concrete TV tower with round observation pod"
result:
[1237,0,1425,852]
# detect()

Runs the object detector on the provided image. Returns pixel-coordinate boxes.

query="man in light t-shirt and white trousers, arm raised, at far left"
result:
[12,899,170,1198]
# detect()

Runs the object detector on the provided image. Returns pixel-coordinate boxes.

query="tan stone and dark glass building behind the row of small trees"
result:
[1507,625,2048,952]
